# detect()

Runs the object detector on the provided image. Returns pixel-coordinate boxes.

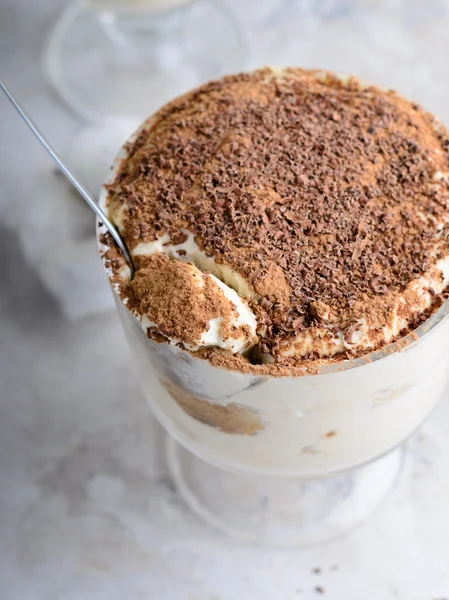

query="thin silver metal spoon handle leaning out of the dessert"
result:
[0,79,133,271]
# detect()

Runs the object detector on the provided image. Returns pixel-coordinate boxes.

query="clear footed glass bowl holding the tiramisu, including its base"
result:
[98,70,449,546]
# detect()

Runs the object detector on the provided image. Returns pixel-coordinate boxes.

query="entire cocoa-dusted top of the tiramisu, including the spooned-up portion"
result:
[103,68,449,374]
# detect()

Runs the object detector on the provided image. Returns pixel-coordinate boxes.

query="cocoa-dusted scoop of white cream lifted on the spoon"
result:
[117,231,258,354]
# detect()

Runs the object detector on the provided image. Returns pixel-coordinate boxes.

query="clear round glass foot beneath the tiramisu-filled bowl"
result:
[167,436,403,547]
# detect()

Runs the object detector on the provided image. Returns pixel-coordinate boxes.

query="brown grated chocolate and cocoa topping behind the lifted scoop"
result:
[108,68,449,370]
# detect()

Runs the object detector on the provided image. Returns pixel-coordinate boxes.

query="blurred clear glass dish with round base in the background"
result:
[44,0,247,122]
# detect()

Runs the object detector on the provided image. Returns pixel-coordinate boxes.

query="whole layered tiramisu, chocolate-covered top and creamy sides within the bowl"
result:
[100,68,449,472]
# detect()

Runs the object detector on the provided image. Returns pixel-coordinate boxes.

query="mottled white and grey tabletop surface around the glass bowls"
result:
[0,0,449,600]
